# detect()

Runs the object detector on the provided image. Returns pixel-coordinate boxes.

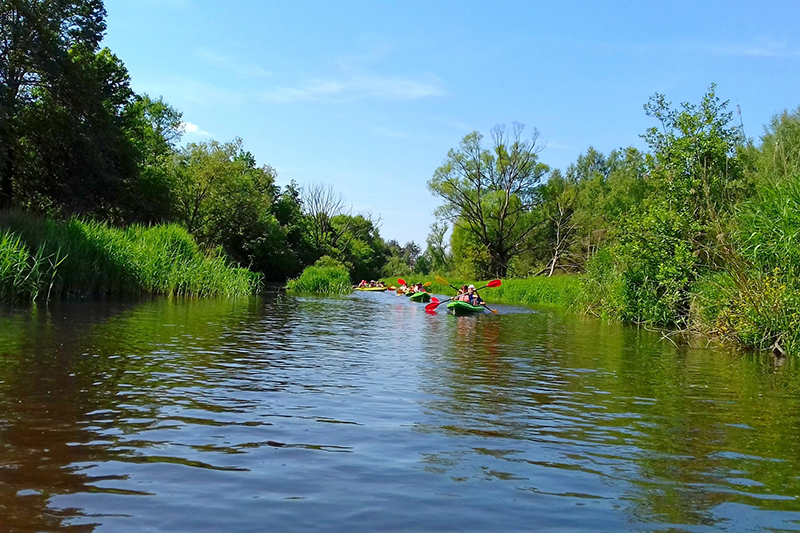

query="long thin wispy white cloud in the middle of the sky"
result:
[261,75,444,103]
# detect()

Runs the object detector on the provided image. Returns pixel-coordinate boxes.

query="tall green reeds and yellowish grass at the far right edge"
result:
[694,176,800,354]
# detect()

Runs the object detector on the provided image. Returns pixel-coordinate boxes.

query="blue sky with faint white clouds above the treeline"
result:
[104,0,800,244]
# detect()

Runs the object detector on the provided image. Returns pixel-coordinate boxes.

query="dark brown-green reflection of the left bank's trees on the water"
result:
[0,299,292,531]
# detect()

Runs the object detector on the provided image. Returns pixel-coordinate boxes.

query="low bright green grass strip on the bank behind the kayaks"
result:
[383,275,583,311]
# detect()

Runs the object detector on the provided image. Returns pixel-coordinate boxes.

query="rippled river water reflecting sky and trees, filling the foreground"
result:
[0,294,800,533]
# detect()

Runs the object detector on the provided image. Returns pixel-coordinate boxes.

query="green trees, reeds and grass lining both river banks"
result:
[0,0,800,356]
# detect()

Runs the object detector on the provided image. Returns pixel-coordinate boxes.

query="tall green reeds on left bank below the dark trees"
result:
[0,211,260,301]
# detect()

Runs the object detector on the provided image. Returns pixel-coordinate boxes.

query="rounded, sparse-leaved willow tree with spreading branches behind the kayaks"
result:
[428,123,549,277]
